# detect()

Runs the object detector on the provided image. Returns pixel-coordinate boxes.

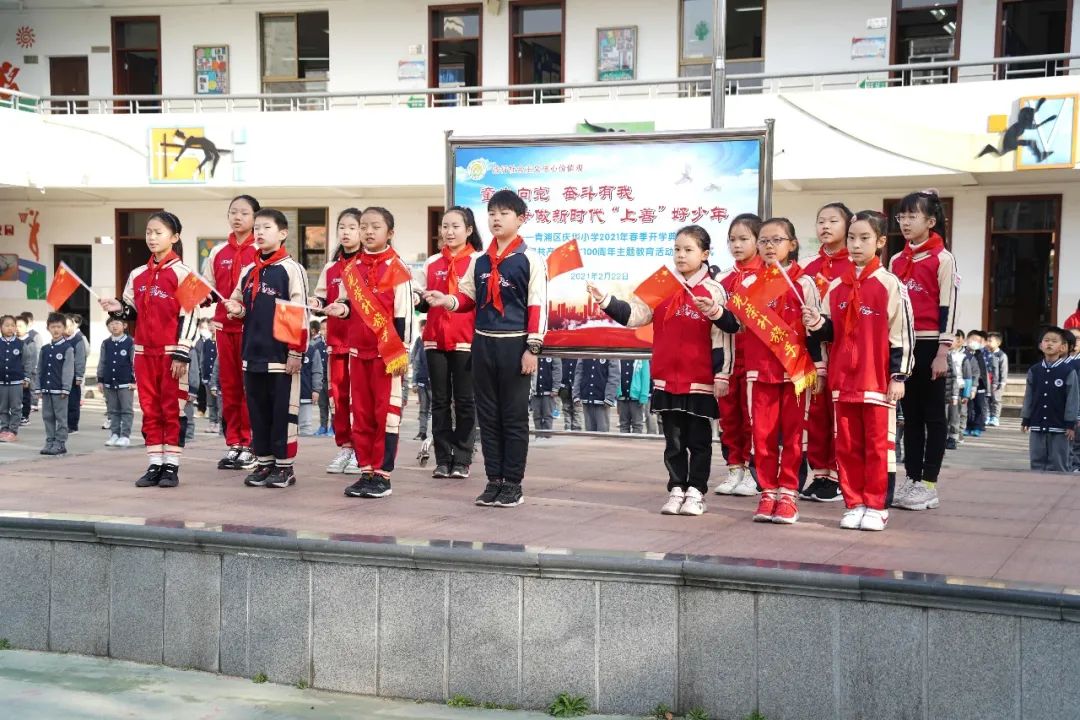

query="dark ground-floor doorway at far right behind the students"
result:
[983,195,1062,369]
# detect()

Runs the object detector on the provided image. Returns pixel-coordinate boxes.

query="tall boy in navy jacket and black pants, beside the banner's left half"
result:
[424,190,548,507]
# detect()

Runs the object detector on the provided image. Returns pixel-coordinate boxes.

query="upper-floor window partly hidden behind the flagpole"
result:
[679,0,766,78]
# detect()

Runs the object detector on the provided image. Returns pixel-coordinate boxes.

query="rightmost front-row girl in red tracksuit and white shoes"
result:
[802,210,915,530]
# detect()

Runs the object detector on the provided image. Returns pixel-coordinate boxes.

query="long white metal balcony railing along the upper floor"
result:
[0,53,1080,114]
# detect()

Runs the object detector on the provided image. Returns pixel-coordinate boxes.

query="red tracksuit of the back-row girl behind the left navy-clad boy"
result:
[202,233,257,448]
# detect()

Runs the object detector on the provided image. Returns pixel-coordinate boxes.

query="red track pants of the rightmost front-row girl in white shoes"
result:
[834,403,896,510]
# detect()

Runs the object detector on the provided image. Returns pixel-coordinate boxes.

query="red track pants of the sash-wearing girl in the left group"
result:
[349,357,402,478]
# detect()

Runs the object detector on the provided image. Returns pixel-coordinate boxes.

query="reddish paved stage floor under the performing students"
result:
[0,400,1080,587]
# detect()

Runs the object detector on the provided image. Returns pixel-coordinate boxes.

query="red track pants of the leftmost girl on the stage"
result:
[135,353,188,464]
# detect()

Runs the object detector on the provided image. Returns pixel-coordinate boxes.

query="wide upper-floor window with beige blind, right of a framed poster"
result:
[259,11,330,93]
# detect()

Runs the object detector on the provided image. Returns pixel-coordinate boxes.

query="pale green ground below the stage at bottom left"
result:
[0,650,630,720]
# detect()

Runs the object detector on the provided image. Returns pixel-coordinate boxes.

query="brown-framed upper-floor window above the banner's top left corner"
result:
[428,5,484,105]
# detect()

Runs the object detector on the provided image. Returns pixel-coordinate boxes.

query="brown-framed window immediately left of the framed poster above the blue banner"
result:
[510,0,564,103]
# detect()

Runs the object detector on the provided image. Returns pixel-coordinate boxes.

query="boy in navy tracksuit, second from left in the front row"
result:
[225,207,308,488]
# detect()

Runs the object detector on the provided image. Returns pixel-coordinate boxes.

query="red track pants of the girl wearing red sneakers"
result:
[746,379,810,492]
